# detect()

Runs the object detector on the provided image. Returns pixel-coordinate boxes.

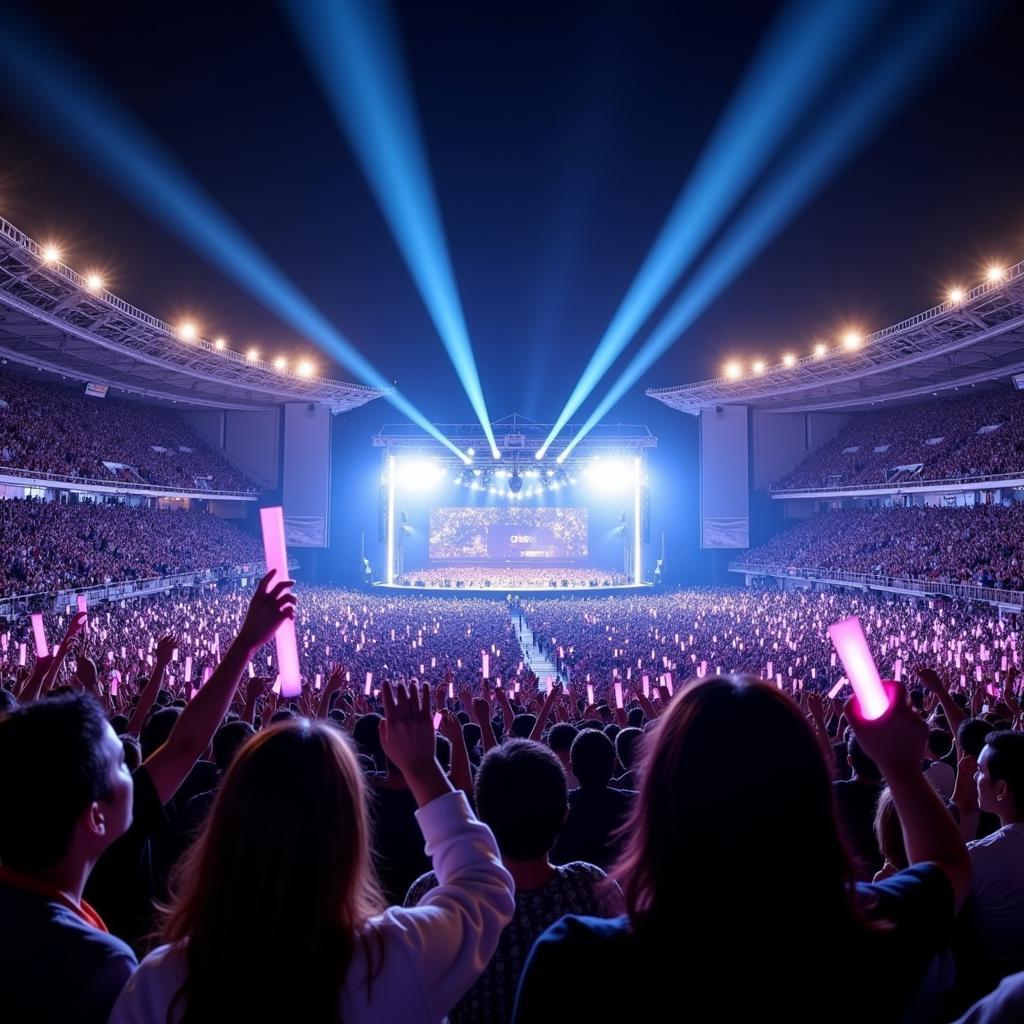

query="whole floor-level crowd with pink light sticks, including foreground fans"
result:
[0,578,1024,1024]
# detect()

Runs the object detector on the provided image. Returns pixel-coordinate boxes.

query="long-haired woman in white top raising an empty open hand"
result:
[111,684,515,1024]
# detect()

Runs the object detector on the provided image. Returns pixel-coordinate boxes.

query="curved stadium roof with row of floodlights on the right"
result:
[647,262,1024,415]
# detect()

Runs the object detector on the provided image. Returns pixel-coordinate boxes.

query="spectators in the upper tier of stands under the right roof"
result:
[775,387,1024,488]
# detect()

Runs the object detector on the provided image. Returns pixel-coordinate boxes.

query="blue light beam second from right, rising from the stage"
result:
[537,0,885,459]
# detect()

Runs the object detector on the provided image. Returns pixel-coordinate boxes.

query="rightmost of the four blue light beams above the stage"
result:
[558,0,967,462]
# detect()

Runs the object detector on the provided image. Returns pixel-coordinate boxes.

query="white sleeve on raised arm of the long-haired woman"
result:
[373,792,515,1019]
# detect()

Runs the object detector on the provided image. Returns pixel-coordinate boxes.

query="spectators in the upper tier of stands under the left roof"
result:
[0,374,258,490]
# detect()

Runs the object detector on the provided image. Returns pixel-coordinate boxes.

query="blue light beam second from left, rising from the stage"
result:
[283,0,500,459]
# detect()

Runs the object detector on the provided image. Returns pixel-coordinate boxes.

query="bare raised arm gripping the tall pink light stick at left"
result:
[143,571,295,804]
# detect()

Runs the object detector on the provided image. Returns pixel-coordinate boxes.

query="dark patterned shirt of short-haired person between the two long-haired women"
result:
[406,860,622,1024]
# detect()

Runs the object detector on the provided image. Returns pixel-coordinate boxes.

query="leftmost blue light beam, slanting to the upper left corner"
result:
[0,11,469,462]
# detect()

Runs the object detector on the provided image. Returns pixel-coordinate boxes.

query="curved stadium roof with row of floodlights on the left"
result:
[0,217,385,413]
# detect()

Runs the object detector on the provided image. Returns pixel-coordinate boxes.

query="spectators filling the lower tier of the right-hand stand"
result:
[740,503,1024,590]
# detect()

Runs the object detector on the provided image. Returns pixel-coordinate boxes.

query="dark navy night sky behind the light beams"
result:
[0,0,1024,434]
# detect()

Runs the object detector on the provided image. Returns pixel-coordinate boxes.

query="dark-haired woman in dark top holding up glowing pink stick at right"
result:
[516,677,970,1022]
